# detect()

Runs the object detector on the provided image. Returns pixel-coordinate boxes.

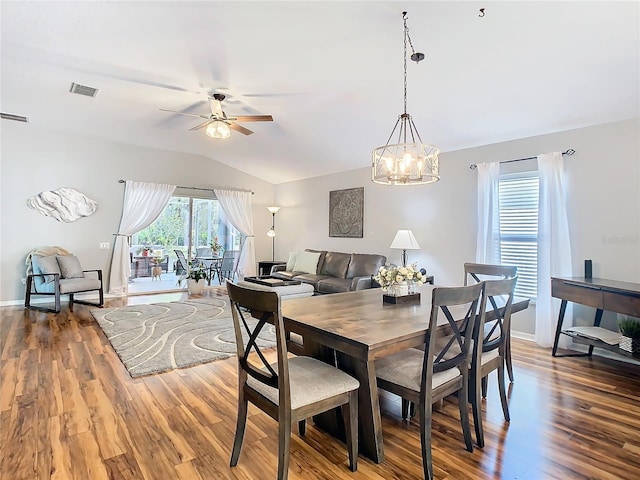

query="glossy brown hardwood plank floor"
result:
[0,294,640,480]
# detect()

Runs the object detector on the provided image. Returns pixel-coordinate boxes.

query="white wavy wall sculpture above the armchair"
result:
[27,188,98,223]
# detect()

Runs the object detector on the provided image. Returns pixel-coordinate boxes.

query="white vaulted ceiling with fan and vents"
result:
[0,1,640,184]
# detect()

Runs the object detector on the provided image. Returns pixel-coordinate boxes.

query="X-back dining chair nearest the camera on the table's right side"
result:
[375,283,484,480]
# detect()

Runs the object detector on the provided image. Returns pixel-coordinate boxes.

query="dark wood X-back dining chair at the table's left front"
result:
[227,281,360,480]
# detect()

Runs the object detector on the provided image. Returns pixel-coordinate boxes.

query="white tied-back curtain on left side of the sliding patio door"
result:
[109,180,176,295]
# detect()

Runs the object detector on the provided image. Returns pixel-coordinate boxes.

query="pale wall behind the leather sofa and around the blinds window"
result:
[276,118,640,334]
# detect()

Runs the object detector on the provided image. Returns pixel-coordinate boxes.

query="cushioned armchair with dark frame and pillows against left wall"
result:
[24,247,104,313]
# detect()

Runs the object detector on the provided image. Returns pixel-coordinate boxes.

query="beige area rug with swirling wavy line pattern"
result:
[91,296,276,377]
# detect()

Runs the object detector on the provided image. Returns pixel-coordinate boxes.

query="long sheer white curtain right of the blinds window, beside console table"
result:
[536,152,573,348]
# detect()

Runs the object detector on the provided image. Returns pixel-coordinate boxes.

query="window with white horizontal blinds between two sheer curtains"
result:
[498,172,539,299]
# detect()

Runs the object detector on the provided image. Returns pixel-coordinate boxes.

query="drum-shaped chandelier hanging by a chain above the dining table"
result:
[371,12,440,185]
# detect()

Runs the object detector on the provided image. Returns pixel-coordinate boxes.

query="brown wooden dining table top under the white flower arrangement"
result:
[282,284,529,360]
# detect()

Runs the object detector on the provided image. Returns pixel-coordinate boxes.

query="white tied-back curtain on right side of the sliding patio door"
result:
[214,189,256,277]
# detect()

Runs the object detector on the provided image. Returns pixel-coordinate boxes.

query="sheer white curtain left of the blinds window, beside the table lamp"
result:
[476,162,500,265]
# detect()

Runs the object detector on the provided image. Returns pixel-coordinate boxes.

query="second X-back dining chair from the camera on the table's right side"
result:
[469,276,518,448]
